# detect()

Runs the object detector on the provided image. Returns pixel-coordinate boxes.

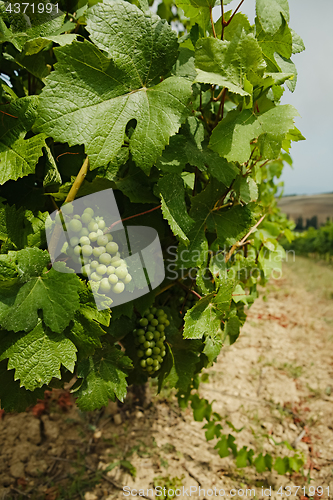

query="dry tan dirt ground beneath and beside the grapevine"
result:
[0,259,333,500]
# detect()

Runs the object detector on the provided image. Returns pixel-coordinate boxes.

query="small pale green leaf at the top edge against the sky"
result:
[256,0,289,33]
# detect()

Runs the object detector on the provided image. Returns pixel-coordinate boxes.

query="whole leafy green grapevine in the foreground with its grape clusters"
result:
[0,0,304,476]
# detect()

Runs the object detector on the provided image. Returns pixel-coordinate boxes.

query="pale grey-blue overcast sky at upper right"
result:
[214,0,333,194]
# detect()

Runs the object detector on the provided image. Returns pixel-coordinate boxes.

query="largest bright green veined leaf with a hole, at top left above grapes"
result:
[35,1,191,173]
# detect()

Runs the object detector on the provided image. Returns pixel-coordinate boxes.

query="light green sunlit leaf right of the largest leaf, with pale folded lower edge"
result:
[195,31,266,96]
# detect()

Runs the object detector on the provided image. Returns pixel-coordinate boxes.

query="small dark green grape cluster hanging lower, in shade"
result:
[133,307,170,375]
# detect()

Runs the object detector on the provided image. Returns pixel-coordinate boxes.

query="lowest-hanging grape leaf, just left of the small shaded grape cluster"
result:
[74,346,132,411]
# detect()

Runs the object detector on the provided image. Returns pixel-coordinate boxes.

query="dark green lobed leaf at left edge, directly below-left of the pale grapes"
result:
[0,248,80,333]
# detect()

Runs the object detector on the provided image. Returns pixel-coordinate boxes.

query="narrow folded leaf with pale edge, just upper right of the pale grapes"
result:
[157,174,194,242]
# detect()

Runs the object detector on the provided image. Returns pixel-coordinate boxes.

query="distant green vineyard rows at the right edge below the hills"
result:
[283,222,333,262]
